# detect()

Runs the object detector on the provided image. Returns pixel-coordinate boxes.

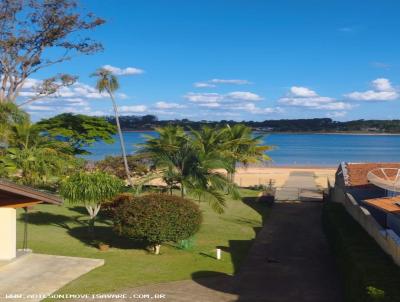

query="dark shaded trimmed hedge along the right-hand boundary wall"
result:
[322,202,400,302]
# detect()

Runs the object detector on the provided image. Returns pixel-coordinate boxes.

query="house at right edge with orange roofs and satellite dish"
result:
[327,163,400,266]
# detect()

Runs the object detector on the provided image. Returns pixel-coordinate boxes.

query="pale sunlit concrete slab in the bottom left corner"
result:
[0,254,104,302]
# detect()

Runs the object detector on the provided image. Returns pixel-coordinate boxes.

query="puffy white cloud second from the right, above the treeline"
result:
[279,86,353,110]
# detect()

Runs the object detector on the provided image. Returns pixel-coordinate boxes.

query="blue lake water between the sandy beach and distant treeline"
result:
[86,132,400,166]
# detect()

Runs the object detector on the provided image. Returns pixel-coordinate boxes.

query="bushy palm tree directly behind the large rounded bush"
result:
[140,125,239,213]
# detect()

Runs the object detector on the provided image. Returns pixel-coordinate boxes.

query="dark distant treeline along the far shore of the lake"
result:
[106,115,400,133]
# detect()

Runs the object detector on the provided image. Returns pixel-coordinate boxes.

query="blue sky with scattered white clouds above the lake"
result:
[22,0,400,120]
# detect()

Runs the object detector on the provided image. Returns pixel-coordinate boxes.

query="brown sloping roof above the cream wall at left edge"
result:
[0,179,62,207]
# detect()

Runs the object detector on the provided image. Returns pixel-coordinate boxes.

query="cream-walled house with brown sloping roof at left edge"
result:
[0,179,62,260]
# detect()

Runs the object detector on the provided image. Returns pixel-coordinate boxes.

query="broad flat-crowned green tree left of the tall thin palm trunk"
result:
[36,113,116,154]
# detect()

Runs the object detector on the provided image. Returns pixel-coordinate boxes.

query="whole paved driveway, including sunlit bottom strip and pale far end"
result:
[73,173,342,302]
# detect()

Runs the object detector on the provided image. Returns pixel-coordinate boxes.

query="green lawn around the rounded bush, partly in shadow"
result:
[18,190,268,293]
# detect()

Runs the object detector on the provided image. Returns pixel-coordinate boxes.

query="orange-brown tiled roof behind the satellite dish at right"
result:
[344,163,400,186]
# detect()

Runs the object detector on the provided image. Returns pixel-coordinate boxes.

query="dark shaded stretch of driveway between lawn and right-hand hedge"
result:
[236,203,341,302]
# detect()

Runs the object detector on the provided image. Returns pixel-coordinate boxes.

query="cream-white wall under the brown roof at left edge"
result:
[0,208,17,260]
